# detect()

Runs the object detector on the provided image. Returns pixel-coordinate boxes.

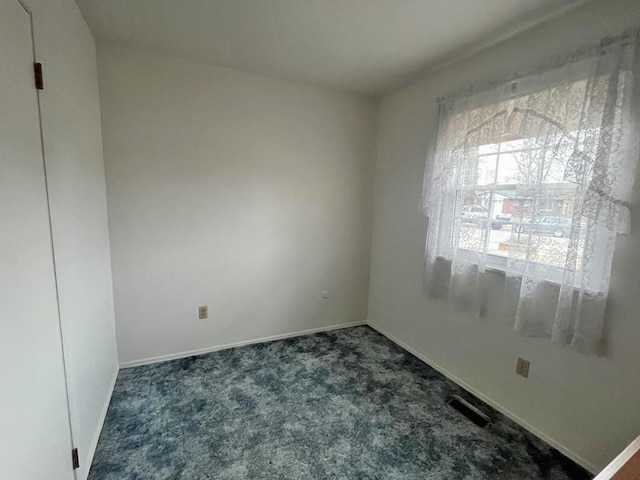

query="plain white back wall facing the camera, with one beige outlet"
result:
[98,45,376,363]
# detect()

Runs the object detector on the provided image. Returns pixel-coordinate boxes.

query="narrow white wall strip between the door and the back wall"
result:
[26,0,118,478]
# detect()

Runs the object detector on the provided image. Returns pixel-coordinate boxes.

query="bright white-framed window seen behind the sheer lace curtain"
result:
[438,78,607,288]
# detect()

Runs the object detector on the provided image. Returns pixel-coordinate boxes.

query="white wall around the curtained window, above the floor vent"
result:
[369,0,640,469]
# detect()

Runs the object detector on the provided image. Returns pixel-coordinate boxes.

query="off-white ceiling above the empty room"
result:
[77,0,583,96]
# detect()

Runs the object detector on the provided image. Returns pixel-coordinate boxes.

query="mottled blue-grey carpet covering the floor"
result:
[89,327,591,480]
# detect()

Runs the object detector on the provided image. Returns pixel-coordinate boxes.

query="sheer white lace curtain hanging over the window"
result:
[423,31,640,353]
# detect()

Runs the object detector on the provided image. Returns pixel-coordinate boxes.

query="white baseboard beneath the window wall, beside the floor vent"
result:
[368,323,600,474]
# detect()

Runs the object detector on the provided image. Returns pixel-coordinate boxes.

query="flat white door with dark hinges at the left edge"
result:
[0,0,74,480]
